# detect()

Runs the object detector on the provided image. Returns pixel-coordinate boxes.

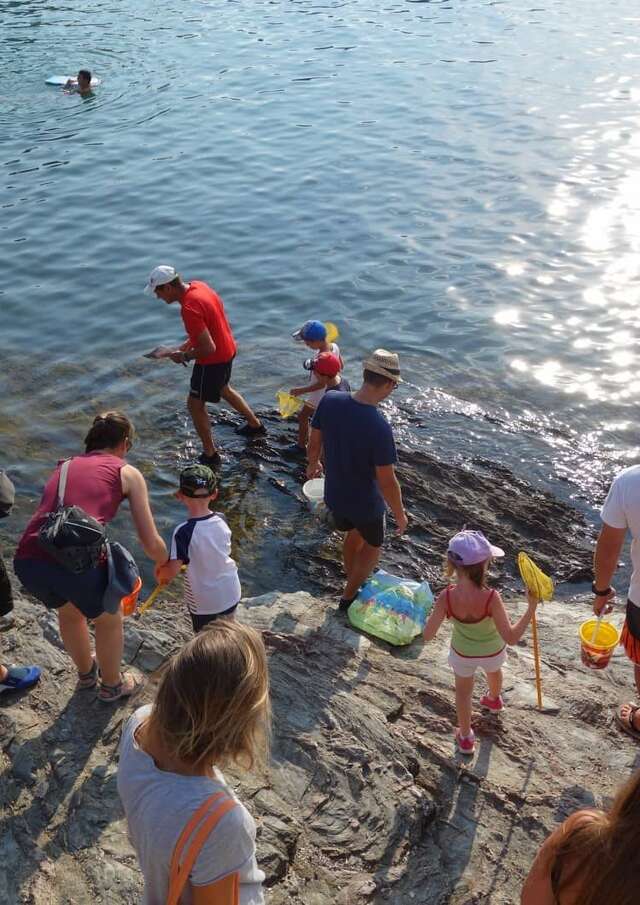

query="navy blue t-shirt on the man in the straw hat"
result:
[311,393,398,524]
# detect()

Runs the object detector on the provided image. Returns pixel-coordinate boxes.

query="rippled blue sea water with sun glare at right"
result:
[0,0,640,587]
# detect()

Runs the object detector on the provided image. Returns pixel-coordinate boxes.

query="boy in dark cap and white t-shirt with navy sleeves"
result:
[156,465,241,632]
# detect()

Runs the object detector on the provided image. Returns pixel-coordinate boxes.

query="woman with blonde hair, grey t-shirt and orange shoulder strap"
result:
[118,619,270,905]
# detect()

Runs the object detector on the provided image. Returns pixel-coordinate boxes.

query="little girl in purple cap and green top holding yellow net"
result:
[424,531,538,754]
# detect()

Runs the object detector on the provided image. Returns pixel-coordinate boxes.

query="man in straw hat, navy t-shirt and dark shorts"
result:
[307,349,407,610]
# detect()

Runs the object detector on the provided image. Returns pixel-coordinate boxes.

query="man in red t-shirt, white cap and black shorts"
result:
[145,264,265,466]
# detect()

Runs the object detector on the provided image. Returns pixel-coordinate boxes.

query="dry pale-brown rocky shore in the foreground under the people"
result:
[0,568,640,905]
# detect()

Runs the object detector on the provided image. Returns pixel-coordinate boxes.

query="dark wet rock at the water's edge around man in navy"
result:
[216,410,594,593]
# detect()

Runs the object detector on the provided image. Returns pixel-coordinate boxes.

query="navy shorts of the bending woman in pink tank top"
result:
[13,559,107,619]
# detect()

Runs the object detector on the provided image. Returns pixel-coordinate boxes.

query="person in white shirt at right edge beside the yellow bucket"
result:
[592,465,640,739]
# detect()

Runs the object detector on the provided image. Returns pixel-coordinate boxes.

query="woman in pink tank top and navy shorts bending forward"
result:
[14,412,167,702]
